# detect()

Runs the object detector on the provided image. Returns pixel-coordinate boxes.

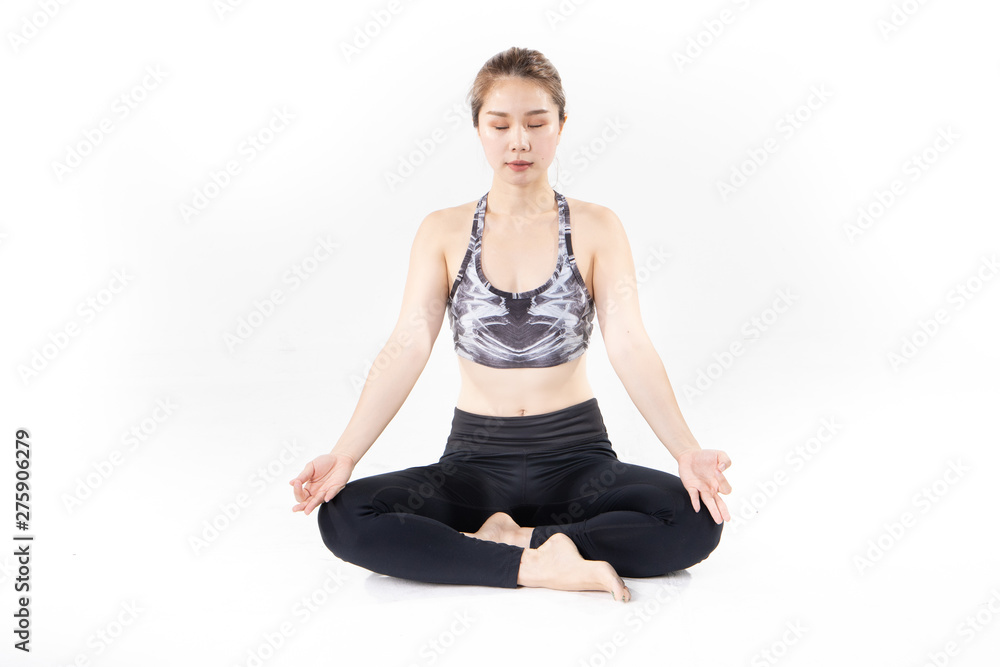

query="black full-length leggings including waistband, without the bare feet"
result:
[317,397,722,588]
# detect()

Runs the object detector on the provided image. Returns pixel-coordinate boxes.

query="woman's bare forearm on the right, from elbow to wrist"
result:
[611,335,701,459]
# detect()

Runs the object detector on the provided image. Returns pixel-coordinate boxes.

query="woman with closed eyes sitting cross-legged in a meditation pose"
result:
[290,47,731,602]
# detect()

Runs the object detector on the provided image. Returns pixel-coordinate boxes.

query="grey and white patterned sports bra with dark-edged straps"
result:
[447,192,595,368]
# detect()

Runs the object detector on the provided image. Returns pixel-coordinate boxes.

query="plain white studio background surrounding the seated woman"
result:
[0,0,1000,666]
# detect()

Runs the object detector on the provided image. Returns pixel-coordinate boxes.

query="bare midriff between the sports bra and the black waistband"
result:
[456,352,594,417]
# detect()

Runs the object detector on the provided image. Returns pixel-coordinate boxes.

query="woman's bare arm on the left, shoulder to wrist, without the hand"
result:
[330,211,448,463]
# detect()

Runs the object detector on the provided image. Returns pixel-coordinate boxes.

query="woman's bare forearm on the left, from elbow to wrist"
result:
[331,339,430,463]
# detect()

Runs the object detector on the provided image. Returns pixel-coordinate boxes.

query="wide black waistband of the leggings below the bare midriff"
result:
[444,396,611,455]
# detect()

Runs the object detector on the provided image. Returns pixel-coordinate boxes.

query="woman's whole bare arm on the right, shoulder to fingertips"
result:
[594,206,732,523]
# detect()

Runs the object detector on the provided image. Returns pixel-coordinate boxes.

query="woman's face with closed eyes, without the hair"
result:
[479,78,562,183]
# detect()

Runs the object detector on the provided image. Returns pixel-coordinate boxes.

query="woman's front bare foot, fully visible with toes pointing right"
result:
[517,533,632,602]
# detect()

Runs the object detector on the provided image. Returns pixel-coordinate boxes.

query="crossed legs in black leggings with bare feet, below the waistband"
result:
[318,452,722,600]
